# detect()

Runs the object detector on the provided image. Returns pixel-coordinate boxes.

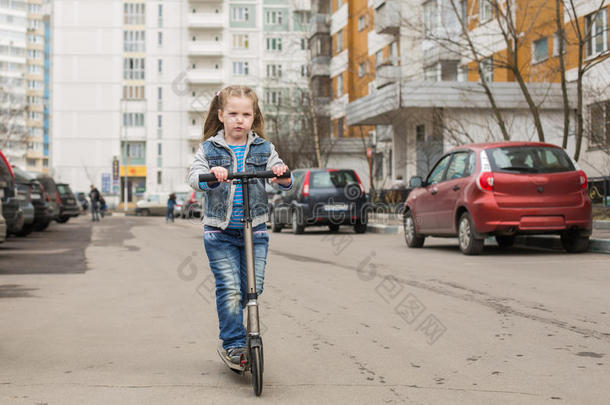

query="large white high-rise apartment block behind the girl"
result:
[51,0,311,204]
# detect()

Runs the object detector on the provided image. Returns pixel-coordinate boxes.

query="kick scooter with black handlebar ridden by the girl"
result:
[199,170,290,396]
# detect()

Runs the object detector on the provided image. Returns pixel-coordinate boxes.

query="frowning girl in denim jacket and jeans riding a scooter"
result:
[188,86,292,364]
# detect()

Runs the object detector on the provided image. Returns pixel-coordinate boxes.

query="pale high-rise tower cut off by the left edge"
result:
[0,0,28,167]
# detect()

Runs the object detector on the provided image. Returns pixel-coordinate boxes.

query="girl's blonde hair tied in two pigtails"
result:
[202,86,265,141]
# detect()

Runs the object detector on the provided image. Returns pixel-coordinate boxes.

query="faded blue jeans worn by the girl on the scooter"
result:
[203,224,269,349]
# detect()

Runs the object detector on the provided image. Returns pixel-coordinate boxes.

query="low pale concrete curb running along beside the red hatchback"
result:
[367,221,610,253]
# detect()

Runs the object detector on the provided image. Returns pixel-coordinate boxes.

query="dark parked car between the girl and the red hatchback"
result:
[270,169,368,234]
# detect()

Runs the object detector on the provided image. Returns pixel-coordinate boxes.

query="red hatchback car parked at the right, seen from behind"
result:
[404,142,592,254]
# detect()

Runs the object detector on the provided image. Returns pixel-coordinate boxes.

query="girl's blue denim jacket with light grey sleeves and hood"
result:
[188,130,292,229]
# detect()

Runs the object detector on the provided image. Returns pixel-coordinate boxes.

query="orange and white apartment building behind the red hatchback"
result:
[340,0,610,183]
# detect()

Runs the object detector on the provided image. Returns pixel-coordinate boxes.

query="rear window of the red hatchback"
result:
[487,146,575,173]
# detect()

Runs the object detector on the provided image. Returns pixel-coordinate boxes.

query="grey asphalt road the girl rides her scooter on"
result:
[0,216,610,404]
